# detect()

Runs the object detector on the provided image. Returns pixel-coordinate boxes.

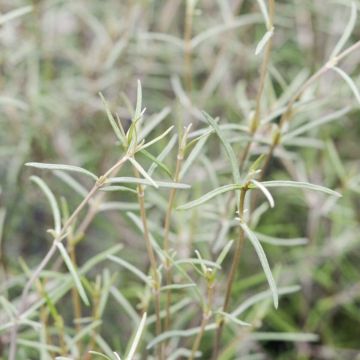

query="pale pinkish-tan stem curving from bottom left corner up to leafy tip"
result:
[9,155,128,360]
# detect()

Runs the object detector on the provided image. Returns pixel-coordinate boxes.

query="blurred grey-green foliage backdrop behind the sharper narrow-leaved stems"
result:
[0,0,360,359]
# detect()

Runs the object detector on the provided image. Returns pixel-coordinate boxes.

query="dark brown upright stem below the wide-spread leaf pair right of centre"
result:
[212,186,247,360]
